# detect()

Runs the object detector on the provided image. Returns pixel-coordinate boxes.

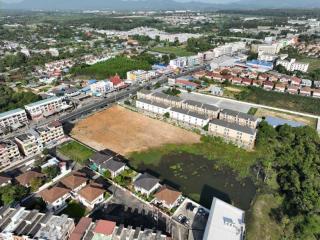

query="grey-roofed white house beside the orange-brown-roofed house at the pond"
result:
[133,173,160,196]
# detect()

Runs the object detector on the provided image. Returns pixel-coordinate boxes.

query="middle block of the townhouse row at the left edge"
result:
[15,130,43,156]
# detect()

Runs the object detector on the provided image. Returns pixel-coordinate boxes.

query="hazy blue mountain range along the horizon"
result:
[0,0,320,10]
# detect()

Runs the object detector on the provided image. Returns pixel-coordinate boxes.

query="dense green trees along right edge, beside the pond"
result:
[257,122,320,240]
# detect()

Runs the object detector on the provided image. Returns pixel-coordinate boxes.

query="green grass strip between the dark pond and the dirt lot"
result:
[129,137,262,178]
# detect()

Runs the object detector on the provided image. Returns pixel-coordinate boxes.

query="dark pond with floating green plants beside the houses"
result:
[130,153,256,210]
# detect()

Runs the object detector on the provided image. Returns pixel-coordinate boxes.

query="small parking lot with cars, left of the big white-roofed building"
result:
[173,199,209,240]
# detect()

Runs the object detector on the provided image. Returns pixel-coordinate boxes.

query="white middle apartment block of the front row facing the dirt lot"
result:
[169,107,210,127]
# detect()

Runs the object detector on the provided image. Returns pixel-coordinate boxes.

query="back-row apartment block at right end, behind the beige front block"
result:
[219,109,258,129]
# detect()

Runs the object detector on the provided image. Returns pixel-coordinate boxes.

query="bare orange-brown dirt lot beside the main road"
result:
[71,106,200,156]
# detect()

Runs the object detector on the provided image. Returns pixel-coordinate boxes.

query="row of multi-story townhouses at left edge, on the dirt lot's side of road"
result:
[0,121,65,166]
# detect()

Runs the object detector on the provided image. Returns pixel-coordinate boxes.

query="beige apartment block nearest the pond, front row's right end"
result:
[208,119,257,149]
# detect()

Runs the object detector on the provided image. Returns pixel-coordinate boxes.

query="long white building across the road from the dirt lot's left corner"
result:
[24,97,70,119]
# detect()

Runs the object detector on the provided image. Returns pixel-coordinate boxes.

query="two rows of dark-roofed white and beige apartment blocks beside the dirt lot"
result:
[136,92,258,149]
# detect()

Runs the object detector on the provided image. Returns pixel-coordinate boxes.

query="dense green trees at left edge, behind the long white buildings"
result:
[0,86,41,112]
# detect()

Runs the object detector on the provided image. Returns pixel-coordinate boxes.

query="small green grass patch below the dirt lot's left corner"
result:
[58,141,94,164]
